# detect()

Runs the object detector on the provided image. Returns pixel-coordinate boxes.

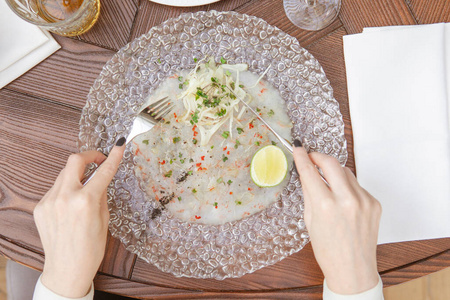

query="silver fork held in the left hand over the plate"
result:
[81,96,175,185]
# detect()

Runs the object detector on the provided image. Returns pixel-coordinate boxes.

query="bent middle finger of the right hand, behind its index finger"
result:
[309,152,349,190]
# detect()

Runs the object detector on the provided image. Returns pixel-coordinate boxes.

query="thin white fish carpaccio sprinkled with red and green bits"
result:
[133,71,292,225]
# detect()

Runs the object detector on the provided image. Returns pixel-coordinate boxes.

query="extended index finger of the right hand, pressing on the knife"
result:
[293,140,330,198]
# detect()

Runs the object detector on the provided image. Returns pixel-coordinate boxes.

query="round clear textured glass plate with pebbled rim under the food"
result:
[78,11,347,279]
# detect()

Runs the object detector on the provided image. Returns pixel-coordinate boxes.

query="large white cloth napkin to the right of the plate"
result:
[344,24,450,244]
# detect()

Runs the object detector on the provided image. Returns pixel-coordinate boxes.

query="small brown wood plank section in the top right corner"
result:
[406,0,450,24]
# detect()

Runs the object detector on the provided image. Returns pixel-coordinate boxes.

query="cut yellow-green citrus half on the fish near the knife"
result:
[250,145,288,187]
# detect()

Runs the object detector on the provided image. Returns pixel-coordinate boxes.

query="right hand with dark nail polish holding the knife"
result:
[294,141,381,294]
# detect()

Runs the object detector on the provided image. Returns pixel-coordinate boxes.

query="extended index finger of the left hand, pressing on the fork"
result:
[85,138,125,195]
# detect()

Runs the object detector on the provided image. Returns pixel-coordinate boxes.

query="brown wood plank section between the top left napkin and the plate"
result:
[6,35,115,108]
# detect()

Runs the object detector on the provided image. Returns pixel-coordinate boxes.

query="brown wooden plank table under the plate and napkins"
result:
[0,0,450,299]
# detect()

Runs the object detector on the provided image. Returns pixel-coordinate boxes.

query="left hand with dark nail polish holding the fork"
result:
[34,138,125,298]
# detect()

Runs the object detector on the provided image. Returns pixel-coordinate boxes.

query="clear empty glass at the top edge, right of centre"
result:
[283,0,341,31]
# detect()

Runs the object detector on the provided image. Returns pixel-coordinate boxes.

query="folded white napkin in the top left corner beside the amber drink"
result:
[0,0,61,89]
